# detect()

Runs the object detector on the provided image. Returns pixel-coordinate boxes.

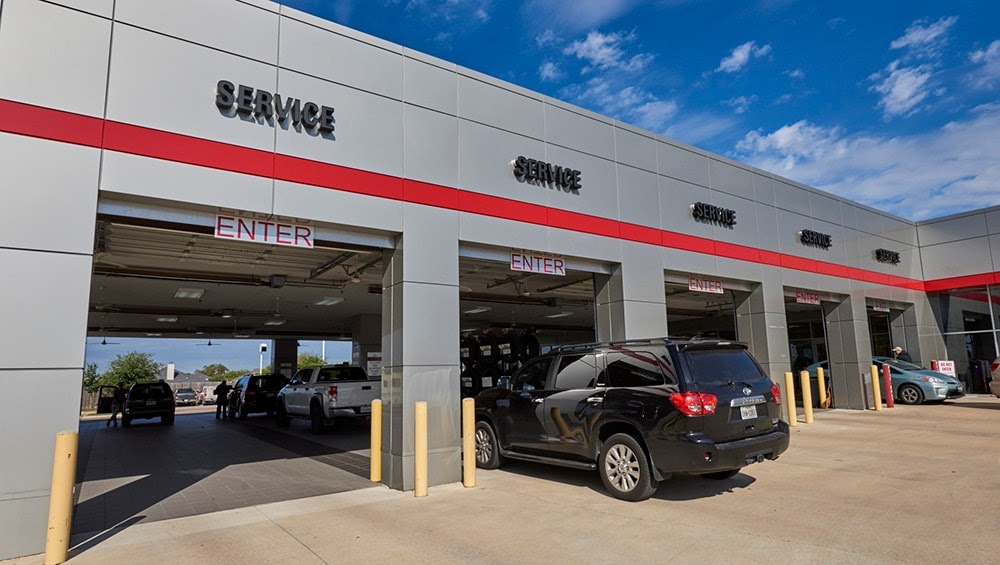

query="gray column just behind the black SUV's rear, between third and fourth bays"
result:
[736,270,792,384]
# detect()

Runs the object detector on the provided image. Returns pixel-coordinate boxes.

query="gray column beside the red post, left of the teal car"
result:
[823,291,872,410]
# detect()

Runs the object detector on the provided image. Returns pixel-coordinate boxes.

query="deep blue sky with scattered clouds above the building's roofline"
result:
[281,0,1000,220]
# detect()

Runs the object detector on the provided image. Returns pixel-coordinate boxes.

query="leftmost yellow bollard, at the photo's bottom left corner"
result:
[45,431,80,565]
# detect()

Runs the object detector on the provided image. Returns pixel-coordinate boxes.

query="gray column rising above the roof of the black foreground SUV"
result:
[594,242,667,341]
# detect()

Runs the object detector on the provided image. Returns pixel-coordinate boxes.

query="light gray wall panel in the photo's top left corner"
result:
[0,0,111,116]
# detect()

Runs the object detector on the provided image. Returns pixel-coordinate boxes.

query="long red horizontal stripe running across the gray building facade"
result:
[0,99,1000,291]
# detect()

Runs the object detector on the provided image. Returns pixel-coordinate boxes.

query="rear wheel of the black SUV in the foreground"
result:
[598,434,657,502]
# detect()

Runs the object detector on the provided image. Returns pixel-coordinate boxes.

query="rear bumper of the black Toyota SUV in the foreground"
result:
[649,421,789,475]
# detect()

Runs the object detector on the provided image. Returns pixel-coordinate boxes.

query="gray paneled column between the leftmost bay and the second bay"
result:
[381,204,462,490]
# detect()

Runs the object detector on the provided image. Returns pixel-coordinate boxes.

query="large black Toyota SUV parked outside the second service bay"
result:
[476,338,789,501]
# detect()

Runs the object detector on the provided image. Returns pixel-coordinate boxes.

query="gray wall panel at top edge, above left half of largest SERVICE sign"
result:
[115,0,278,65]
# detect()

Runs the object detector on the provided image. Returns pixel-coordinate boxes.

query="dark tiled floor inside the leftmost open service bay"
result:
[73,408,371,535]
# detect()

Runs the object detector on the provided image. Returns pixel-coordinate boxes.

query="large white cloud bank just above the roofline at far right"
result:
[734,104,1000,220]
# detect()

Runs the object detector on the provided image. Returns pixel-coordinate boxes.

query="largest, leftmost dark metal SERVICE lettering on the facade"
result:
[215,80,336,134]
